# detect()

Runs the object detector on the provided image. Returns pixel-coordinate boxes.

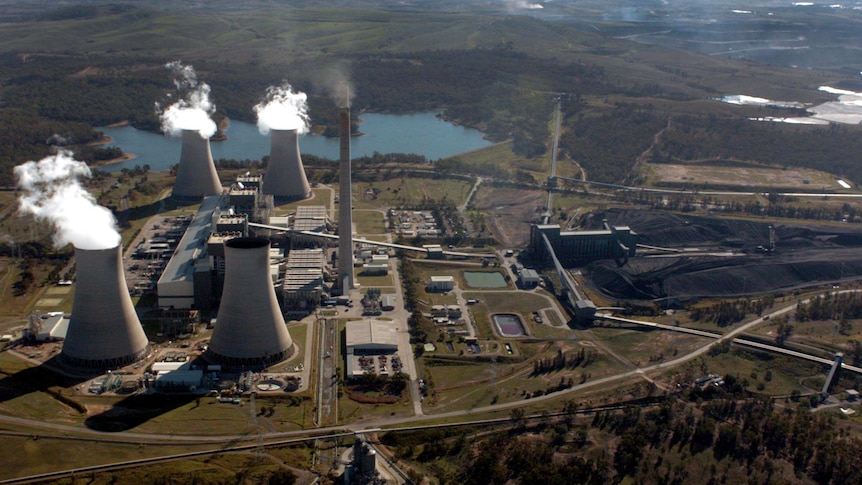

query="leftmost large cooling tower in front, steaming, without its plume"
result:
[60,246,148,369]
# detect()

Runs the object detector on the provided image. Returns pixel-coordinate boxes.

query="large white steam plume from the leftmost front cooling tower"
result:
[15,150,121,249]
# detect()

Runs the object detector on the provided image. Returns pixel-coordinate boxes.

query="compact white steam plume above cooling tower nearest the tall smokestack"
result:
[254,82,309,135]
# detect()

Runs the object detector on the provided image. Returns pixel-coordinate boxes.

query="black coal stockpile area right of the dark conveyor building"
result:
[581,210,862,301]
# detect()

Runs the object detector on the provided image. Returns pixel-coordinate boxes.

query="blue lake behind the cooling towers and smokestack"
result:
[99,113,492,172]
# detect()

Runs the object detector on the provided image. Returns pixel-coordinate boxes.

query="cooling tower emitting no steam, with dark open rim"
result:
[206,237,293,368]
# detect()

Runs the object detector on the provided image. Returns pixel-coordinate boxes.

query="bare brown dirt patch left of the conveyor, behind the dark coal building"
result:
[471,183,545,247]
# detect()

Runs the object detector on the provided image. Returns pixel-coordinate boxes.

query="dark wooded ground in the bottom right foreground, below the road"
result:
[381,398,862,485]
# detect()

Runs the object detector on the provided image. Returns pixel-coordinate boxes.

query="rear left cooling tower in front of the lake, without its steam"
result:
[171,130,222,200]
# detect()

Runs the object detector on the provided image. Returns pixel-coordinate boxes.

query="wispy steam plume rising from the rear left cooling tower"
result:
[156,61,216,138]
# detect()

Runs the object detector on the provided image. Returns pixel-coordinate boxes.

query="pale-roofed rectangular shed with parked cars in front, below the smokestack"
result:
[344,319,400,378]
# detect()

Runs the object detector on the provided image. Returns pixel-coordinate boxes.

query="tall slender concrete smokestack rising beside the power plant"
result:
[337,94,355,295]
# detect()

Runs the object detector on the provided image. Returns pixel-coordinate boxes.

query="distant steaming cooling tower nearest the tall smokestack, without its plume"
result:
[261,130,311,203]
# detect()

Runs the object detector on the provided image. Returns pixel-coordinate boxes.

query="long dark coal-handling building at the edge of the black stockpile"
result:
[530,222,638,267]
